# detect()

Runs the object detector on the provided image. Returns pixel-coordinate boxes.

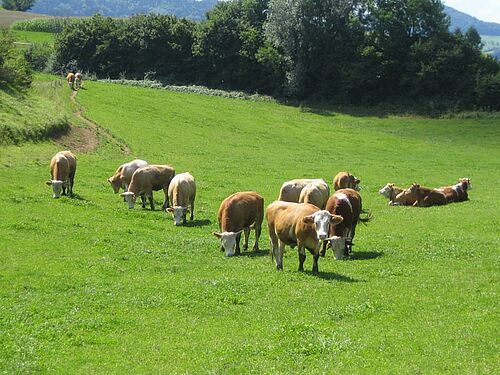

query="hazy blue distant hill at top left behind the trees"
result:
[31,0,218,20]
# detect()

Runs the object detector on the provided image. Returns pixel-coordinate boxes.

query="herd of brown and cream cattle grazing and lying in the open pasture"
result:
[47,151,471,272]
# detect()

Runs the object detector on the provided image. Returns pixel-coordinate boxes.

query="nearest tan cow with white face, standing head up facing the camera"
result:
[266,201,342,272]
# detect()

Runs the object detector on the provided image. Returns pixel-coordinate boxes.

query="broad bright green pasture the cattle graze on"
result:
[0,78,500,374]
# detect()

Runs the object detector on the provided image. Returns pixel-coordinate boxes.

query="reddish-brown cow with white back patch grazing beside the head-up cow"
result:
[321,189,369,259]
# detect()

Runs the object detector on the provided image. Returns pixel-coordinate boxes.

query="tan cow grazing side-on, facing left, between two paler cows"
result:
[120,165,175,211]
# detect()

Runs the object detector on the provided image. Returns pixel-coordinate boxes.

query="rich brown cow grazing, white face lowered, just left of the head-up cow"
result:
[213,191,264,257]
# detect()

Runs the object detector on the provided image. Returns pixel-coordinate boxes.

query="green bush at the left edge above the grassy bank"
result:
[0,28,32,88]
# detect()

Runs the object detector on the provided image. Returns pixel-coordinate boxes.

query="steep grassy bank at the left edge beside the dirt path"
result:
[0,76,71,145]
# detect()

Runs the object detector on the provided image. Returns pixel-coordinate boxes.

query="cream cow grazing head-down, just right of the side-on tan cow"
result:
[167,172,196,225]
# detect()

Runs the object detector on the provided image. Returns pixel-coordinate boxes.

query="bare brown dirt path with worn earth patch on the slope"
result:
[55,91,130,154]
